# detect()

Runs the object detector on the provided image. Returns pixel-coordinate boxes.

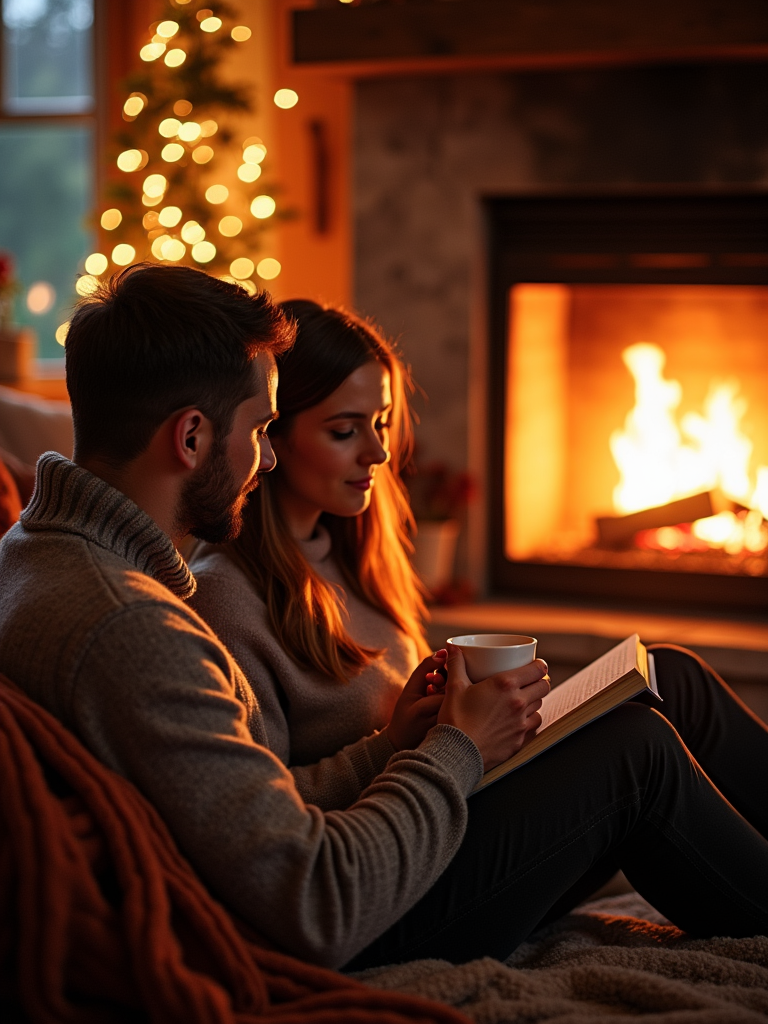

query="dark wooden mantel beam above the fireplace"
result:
[292,0,768,75]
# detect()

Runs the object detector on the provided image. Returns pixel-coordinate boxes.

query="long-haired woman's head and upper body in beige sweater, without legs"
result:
[193,301,448,810]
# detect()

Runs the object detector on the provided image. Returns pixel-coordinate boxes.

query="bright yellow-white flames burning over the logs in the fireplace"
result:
[610,344,768,553]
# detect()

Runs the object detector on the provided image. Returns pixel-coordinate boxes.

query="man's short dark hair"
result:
[66,263,295,465]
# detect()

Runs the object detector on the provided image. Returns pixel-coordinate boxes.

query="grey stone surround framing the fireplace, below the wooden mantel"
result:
[352,61,768,708]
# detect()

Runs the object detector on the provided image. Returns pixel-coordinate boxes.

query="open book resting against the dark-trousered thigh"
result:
[472,633,662,793]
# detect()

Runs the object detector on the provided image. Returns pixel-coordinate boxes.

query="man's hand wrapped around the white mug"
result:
[437,647,550,771]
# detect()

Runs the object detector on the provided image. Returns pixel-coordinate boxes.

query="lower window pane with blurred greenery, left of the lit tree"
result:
[0,122,93,358]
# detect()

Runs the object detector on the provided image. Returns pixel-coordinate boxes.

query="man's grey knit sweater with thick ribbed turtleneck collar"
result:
[0,453,482,967]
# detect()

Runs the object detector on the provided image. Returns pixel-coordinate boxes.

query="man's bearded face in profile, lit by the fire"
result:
[179,352,278,544]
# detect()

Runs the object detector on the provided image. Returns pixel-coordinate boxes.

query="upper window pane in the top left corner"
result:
[2,0,93,114]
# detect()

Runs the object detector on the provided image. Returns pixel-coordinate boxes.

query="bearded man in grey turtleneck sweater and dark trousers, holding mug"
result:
[0,265,768,967]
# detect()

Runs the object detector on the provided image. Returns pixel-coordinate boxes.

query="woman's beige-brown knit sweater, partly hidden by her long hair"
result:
[190,526,418,811]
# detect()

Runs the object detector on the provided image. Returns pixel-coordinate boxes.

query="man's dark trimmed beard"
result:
[176,437,259,544]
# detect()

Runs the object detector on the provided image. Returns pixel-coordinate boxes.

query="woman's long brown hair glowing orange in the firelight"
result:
[226,300,428,682]
